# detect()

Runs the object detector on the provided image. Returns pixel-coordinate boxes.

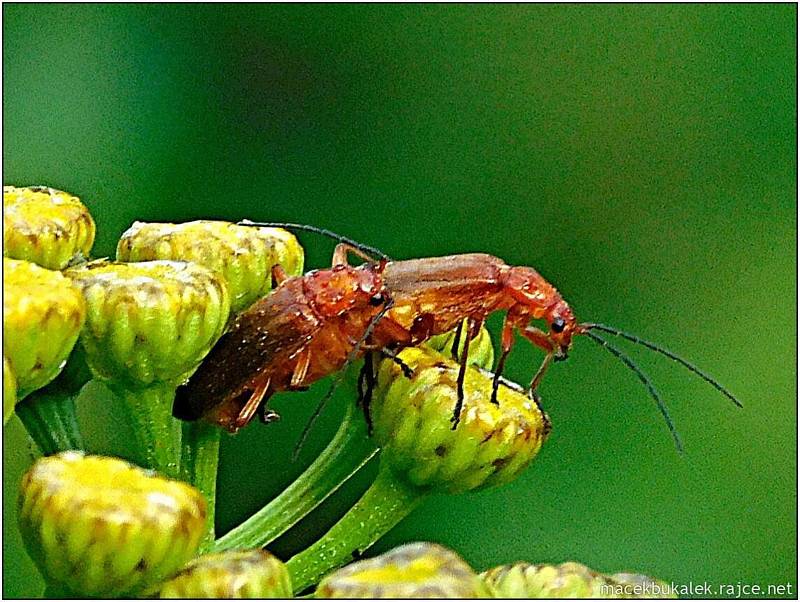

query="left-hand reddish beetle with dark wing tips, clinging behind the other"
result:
[173,256,389,432]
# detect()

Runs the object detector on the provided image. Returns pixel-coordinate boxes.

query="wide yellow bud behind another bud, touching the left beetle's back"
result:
[117,220,303,312]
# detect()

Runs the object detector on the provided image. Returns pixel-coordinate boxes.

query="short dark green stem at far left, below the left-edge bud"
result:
[15,387,86,456]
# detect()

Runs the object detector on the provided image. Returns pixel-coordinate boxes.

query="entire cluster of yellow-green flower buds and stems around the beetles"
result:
[3,187,676,598]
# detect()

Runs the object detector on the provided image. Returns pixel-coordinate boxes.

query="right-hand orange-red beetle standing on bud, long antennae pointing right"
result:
[241,221,742,451]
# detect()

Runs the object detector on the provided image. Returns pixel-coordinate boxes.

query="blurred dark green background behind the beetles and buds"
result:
[3,4,797,596]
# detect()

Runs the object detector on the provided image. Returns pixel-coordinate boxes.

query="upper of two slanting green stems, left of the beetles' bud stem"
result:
[214,404,378,552]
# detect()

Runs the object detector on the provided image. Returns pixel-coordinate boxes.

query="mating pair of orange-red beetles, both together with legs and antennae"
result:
[174,222,741,449]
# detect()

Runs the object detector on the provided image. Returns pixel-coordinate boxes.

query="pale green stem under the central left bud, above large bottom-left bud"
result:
[109,383,181,479]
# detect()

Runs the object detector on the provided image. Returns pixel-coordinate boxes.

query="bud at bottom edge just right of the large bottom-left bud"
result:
[160,550,292,599]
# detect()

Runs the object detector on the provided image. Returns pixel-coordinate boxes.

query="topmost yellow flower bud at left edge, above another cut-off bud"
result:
[3,186,95,270]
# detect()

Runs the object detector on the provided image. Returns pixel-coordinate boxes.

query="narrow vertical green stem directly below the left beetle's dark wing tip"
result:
[181,421,221,553]
